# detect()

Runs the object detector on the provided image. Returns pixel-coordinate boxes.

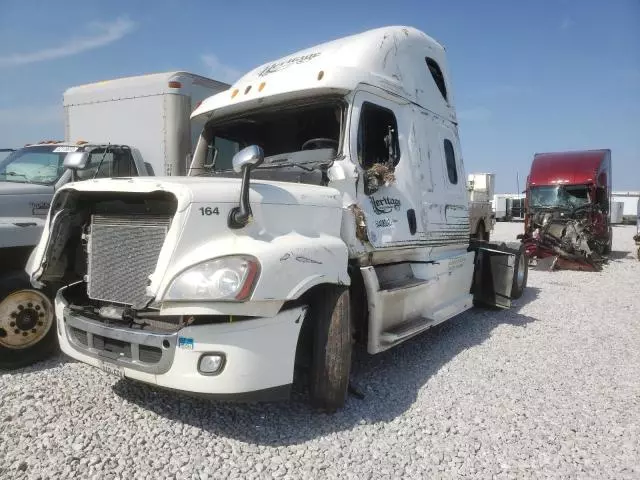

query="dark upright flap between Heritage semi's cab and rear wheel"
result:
[471,247,516,308]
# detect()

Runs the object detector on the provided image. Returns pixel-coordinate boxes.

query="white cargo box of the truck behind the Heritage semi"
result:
[64,71,229,175]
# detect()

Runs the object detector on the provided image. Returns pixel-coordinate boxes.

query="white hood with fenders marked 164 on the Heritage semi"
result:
[26,173,350,315]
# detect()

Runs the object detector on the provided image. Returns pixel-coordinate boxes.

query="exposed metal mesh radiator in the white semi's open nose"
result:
[87,215,171,305]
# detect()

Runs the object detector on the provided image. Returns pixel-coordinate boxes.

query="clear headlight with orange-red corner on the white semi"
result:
[164,255,260,301]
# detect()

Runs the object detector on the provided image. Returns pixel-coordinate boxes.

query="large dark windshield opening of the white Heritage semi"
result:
[200,97,344,172]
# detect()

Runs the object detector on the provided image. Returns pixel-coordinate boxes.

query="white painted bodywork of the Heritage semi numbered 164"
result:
[27,27,516,393]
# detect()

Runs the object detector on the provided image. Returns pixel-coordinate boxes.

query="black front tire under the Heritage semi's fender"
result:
[309,286,353,413]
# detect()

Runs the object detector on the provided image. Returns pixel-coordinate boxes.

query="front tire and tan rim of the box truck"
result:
[0,271,58,370]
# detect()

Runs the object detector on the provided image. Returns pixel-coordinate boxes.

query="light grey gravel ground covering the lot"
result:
[0,223,640,479]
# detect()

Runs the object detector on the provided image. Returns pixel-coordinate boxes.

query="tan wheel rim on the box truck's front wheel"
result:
[0,290,54,350]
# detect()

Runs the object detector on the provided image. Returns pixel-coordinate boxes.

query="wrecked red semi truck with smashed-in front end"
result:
[518,149,612,270]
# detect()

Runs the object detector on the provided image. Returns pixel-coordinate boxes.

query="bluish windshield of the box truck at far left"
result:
[0,145,67,185]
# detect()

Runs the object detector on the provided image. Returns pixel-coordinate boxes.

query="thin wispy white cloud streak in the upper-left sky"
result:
[0,17,136,68]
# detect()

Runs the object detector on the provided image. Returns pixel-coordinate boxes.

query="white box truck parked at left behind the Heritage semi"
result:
[0,72,229,368]
